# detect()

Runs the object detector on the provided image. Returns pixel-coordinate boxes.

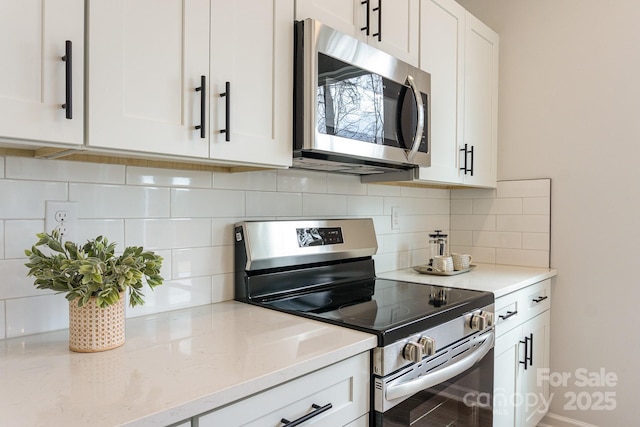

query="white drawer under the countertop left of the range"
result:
[198,353,370,427]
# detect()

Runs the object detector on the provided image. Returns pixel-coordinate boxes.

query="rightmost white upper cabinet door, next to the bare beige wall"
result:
[460,13,498,187]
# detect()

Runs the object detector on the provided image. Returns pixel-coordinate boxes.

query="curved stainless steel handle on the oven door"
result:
[385,331,494,400]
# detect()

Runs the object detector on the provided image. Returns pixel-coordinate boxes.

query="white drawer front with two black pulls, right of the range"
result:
[495,279,551,337]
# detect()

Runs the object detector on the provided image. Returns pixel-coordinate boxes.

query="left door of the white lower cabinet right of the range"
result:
[493,328,522,427]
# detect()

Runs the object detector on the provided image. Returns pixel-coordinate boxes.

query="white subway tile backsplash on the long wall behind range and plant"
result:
[0,157,450,339]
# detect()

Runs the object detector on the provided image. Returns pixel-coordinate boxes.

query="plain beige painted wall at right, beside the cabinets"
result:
[458,0,640,427]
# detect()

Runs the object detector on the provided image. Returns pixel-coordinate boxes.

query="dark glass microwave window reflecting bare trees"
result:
[316,53,408,148]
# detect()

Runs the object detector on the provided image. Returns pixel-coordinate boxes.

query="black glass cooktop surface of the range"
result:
[259,279,494,346]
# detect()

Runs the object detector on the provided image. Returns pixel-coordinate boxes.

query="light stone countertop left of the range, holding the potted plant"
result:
[0,301,377,427]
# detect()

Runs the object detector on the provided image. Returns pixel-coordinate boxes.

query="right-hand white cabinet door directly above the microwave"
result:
[369,0,421,67]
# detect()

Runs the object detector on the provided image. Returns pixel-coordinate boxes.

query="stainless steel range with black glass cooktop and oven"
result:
[235,219,494,427]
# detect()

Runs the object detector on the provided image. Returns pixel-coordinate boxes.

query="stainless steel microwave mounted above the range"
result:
[293,19,431,175]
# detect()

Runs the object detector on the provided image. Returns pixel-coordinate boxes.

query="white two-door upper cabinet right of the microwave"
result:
[419,0,499,187]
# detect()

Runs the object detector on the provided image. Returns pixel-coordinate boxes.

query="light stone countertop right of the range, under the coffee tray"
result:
[378,264,558,298]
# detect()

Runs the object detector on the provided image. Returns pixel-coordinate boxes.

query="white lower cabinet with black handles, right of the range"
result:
[493,280,551,427]
